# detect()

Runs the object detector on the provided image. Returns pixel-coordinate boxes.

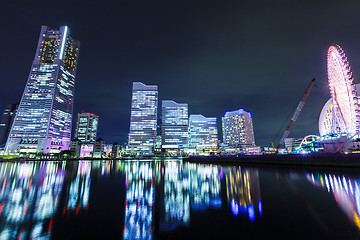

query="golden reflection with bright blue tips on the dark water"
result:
[222,167,262,221]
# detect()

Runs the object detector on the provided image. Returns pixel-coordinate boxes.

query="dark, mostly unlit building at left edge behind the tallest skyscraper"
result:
[0,104,19,147]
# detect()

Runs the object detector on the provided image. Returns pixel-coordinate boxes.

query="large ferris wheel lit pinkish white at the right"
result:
[327,45,360,134]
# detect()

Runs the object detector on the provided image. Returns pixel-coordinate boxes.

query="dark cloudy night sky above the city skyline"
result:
[0,0,360,146]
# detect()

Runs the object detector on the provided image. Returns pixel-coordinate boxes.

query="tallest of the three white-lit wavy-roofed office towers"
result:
[127,82,158,154]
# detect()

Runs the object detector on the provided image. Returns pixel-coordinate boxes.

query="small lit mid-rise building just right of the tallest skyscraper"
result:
[75,113,99,143]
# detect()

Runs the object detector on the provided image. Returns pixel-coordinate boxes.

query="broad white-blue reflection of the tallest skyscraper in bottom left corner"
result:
[0,162,65,239]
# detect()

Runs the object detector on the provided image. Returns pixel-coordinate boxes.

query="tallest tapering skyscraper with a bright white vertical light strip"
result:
[5,26,80,153]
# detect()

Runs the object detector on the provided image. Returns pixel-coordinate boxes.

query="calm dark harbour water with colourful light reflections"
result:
[0,160,360,239]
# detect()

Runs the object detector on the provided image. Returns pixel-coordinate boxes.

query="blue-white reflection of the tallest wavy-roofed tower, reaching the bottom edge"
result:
[123,161,155,239]
